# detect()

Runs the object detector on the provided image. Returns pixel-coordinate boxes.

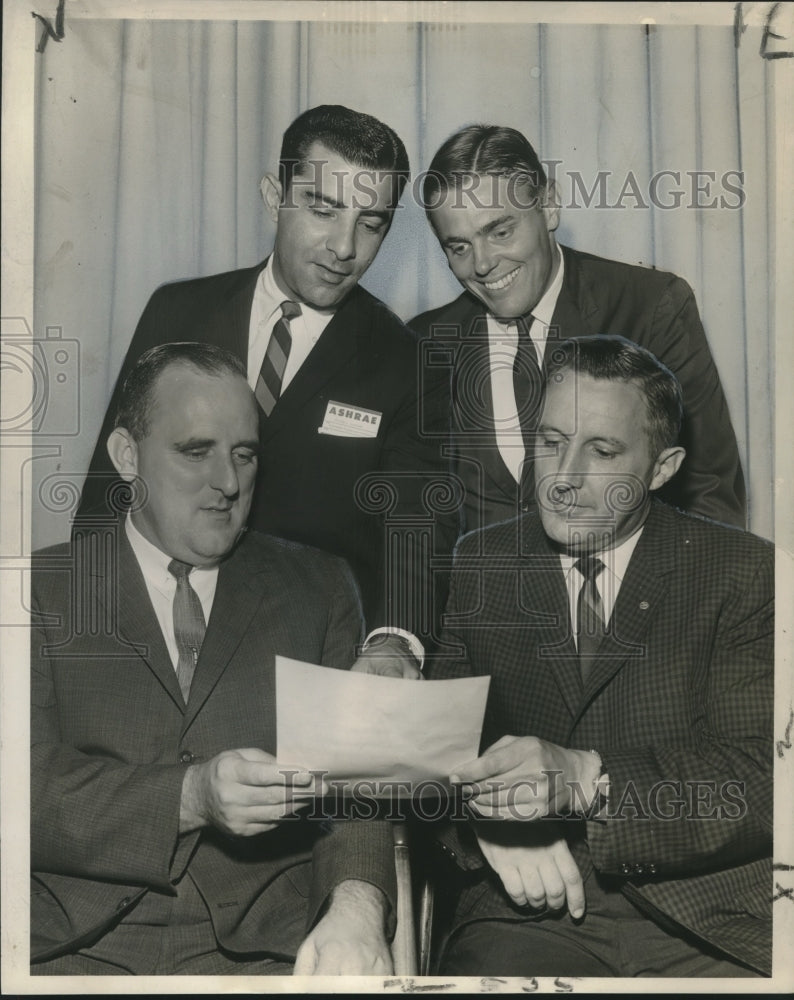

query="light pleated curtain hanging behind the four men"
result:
[33,19,774,545]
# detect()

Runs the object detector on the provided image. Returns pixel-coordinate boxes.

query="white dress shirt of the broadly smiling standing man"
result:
[488,236,564,483]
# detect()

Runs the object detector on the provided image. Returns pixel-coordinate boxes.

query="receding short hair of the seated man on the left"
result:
[114,341,246,441]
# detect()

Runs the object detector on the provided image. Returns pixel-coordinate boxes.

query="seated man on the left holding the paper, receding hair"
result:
[31,343,395,975]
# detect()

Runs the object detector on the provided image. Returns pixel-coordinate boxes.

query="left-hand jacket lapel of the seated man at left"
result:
[94,521,184,708]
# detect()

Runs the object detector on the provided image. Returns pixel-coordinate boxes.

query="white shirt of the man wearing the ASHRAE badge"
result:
[247,255,334,392]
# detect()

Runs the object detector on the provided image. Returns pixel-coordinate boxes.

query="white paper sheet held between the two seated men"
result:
[276,656,490,794]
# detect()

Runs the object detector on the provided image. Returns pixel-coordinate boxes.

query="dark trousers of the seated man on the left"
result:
[30,875,302,976]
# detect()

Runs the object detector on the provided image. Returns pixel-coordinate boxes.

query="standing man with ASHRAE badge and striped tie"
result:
[77,106,456,658]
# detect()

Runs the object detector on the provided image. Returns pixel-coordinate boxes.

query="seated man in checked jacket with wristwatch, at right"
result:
[432,337,774,976]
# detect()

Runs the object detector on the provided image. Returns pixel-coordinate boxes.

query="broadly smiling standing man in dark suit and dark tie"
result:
[409,125,746,530]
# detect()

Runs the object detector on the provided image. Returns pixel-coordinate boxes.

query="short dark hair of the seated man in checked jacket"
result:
[546,336,684,457]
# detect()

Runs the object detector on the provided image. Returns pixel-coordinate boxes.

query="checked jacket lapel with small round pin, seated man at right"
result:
[582,503,676,709]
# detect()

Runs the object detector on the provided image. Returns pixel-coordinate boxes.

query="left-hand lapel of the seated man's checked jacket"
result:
[520,515,582,717]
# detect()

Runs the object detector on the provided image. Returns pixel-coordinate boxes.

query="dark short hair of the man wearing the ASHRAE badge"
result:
[278,104,411,208]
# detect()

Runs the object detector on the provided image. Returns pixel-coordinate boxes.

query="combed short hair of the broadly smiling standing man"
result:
[422,125,548,215]
